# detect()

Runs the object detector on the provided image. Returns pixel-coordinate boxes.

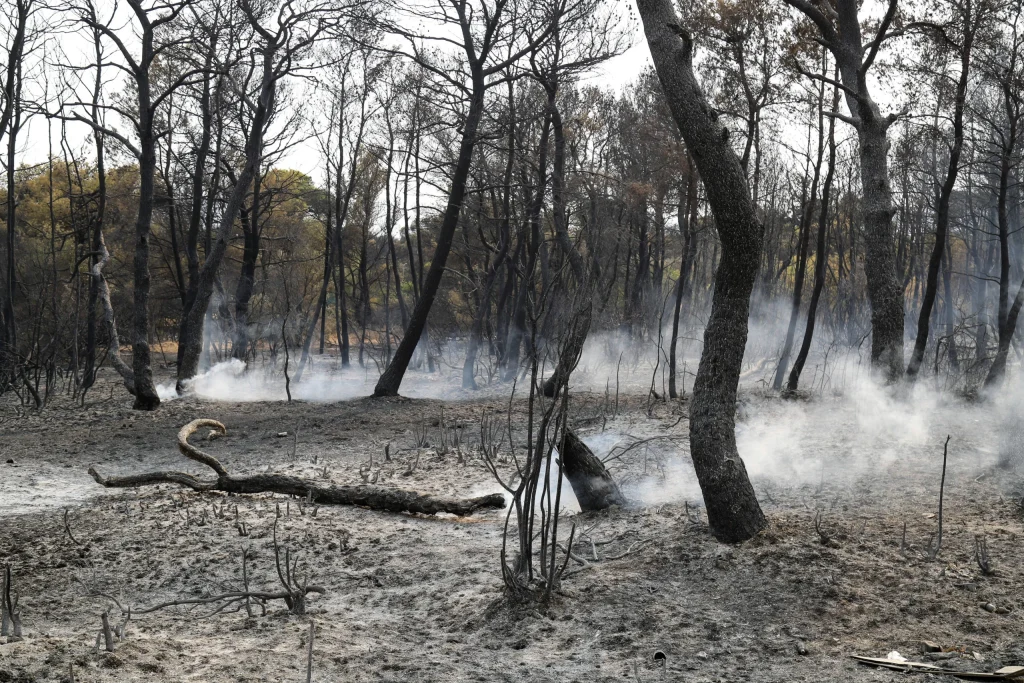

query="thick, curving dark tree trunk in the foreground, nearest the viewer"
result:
[637,0,767,542]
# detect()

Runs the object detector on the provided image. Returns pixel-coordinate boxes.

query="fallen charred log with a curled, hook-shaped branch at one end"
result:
[89,420,505,517]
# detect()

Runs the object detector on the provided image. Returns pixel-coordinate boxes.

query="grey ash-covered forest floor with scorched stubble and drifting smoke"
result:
[0,360,1024,683]
